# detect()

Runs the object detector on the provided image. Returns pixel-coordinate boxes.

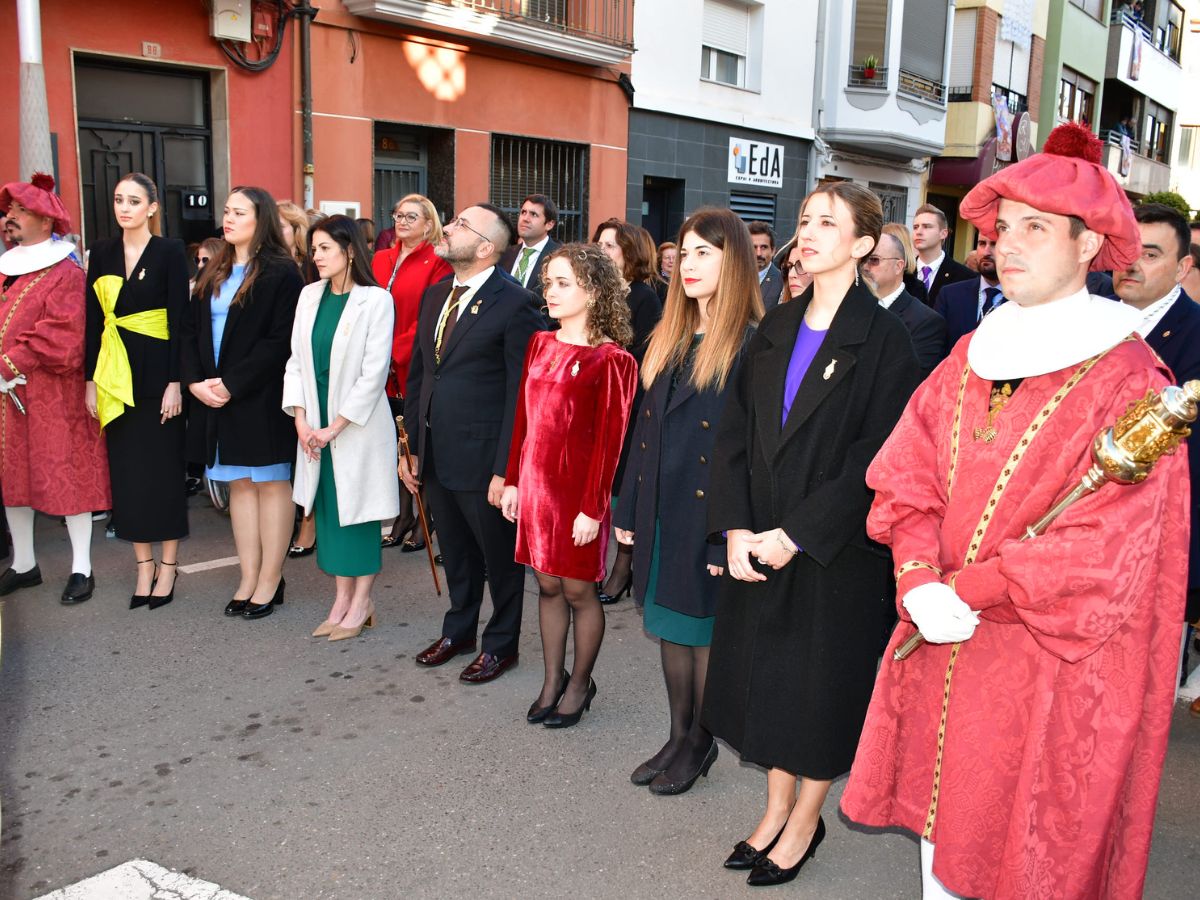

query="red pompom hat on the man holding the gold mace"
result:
[959,122,1141,271]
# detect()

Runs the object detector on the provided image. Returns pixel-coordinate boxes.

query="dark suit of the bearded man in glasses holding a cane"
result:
[404,269,541,656]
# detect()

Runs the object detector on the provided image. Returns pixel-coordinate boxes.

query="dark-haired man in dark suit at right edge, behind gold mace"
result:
[1112,203,1200,715]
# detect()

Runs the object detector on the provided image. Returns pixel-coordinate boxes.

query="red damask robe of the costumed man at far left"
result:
[0,259,110,516]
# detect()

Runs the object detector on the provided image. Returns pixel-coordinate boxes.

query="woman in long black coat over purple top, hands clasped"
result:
[703,181,920,884]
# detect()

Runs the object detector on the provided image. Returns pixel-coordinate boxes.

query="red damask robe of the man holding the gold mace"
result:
[842,340,1188,900]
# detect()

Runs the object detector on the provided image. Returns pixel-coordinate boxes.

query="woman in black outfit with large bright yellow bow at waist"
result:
[84,172,187,610]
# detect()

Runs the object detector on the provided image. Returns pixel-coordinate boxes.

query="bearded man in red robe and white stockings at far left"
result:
[0,174,110,604]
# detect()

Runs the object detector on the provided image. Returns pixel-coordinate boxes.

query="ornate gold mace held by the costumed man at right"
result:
[892,380,1200,661]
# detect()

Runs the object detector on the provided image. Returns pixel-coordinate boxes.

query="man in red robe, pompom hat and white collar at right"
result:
[842,125,1188,900]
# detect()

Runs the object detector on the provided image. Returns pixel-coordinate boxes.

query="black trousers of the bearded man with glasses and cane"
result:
[421,442,524,656]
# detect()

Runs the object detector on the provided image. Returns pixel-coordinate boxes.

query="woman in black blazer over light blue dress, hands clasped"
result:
[182,187,304,619]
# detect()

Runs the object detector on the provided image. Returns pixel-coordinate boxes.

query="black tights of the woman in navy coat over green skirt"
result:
[646,641,713,780]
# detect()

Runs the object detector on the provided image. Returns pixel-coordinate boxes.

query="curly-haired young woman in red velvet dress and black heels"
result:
[500,244,637,728]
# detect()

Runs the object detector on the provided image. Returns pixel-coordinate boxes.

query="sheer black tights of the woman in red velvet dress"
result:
[535,571,604,713]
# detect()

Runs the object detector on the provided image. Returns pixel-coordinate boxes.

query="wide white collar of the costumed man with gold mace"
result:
[969,285,1141,380]
